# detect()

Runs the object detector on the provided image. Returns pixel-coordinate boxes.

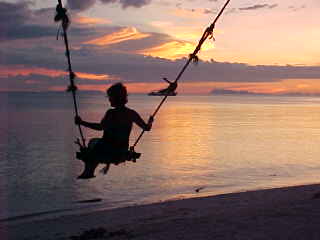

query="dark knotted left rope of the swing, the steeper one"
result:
[54,0,86,147]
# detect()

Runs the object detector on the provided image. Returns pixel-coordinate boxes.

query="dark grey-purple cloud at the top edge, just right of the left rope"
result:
[67,0,151,11]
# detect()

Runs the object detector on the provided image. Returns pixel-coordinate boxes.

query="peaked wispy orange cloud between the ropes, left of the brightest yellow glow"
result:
[85,27,150,46]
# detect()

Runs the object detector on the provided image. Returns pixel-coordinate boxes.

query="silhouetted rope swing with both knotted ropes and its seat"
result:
[54,0,230,177]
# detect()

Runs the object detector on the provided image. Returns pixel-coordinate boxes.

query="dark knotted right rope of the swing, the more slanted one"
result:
[130,0,231,151]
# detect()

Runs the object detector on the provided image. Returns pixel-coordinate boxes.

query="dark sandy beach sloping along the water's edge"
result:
[0,185,320,240]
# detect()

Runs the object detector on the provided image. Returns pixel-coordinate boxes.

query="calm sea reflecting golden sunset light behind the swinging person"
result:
[0,93,320,219]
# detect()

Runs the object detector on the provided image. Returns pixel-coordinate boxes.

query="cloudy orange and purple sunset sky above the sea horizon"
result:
[0,0,320,94]
